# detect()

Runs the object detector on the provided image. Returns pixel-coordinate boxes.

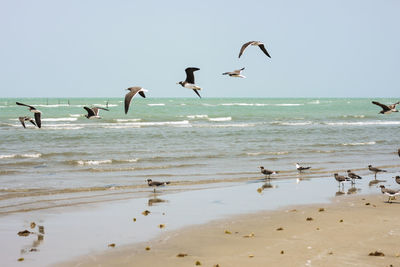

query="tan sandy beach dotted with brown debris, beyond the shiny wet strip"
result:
[61,194,400,266]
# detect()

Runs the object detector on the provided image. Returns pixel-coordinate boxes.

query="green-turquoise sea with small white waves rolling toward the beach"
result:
[0,98,400,214]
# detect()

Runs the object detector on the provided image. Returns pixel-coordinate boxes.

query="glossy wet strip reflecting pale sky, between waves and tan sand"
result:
[0,174,398,266]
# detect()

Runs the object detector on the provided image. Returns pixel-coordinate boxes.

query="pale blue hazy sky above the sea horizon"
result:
[0,0,400,97]
